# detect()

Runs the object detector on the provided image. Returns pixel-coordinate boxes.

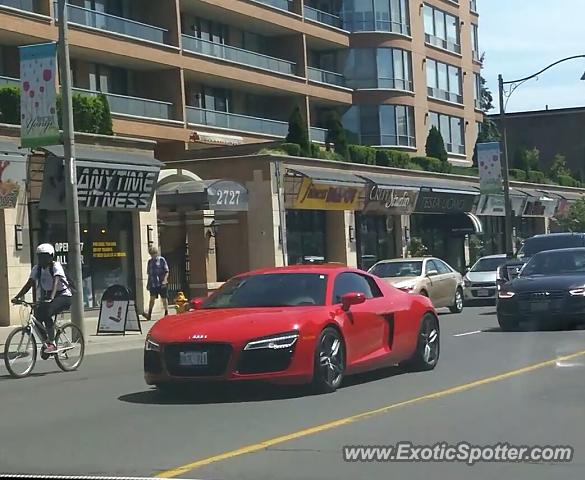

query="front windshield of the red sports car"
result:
[203,273,327,309]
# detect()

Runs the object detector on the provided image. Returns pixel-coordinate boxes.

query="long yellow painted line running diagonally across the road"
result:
[157,350,585,478]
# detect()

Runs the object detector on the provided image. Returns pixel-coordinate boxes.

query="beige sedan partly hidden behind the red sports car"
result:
[368,257,463,313]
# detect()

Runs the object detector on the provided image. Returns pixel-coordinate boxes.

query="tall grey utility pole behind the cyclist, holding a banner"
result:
[57,0,85,333]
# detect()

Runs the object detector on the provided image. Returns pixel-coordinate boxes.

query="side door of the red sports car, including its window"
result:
[333,272,386,364]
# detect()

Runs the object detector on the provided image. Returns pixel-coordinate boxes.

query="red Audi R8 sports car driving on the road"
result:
[144,265,439,392]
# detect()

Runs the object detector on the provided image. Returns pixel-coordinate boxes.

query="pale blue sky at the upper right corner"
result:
[478,0,585,113]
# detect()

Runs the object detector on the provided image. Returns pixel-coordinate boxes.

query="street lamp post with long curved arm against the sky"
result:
[498,55,585,256]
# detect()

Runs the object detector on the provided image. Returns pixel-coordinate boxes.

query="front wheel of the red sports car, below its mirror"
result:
[313,327,345,393]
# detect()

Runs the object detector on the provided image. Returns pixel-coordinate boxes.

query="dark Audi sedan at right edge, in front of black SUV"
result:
[497,248,585,331]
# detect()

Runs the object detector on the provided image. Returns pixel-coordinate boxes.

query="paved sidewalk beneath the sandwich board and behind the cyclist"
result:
[0,310,169,355]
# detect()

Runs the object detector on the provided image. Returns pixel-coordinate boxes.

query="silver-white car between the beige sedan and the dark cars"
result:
[463,254,506,303]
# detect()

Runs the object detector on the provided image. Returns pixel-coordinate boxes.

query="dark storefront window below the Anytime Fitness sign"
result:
[30,204,136,308]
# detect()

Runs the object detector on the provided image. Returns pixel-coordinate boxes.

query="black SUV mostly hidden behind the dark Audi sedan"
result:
[496,233,585,286]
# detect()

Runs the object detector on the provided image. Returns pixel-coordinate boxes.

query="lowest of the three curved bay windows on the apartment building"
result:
[343,105,416,147]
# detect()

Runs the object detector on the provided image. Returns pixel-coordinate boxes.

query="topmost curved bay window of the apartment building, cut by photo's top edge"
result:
[343,0,410,35]
